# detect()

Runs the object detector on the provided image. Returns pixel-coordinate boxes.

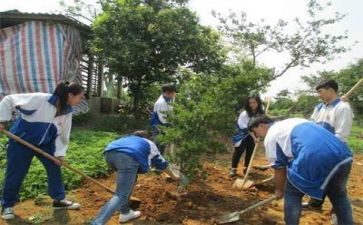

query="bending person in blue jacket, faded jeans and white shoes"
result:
[92,131,179,225]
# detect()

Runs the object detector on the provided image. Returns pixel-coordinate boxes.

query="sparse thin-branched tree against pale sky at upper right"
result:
[213,0,347,88]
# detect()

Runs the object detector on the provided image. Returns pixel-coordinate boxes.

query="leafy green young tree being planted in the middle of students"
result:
[159,61,270,184]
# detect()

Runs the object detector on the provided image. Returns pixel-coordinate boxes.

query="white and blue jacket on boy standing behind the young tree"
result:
[151,95,173,128]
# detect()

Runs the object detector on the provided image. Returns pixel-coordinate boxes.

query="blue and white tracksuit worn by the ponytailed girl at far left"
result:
[0,93,72,207]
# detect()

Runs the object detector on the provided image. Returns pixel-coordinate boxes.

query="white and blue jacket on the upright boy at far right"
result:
[311,98,354,143]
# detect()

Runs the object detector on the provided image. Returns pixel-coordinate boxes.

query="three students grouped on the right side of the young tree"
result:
[230,80,353,225]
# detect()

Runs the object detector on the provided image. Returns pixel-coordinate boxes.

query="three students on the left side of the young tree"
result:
[0,82,179,225]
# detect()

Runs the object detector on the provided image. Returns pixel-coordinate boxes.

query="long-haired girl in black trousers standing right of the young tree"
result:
[229,95,265,177]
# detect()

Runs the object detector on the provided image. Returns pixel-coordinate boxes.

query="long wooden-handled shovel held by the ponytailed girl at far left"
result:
[2,129,141,209]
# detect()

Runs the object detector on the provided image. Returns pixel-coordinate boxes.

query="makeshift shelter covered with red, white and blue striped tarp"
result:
[0,10,102,112]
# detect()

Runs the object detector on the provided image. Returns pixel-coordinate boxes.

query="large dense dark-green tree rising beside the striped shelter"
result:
[92,0,224,112]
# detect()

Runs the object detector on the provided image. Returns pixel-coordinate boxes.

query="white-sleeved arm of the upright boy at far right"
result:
[335,103,353,142]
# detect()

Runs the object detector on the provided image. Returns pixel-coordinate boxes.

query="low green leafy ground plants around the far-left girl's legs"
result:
[0,129,117,199]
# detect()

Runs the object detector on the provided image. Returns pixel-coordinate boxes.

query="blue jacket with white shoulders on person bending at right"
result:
[264,118,352,199]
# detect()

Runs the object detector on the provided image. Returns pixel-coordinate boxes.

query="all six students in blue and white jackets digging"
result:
[0,80,353,225]
